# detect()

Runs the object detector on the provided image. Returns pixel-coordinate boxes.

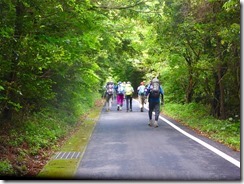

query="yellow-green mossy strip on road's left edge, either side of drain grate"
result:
[37,101,102,179]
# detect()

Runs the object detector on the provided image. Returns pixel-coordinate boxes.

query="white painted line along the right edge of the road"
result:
[142,103,240,168]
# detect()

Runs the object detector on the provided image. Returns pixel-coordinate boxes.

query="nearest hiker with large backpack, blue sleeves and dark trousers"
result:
[146,77,164,128]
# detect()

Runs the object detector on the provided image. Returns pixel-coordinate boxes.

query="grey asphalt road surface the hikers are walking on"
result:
[75,101,241,180]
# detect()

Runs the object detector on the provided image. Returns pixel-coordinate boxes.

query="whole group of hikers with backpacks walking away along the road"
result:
[105,77,164,127]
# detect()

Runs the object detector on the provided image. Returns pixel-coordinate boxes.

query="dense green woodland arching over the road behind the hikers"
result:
[0,0,241,177]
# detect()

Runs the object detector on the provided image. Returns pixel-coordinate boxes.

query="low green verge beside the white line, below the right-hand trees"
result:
[163,103,240,151]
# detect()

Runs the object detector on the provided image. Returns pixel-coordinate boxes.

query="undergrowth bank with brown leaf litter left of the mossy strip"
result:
[0,99,104,179]
